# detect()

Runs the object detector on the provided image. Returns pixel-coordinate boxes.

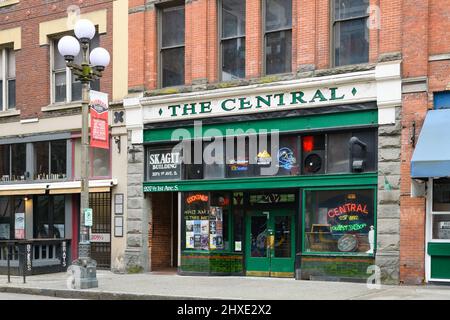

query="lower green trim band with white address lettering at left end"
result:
[144,172,378,192]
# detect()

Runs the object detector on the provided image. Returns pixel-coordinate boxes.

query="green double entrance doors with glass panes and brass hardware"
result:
[245,209,295,277]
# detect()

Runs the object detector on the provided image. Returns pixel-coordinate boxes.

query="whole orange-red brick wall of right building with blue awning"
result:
[400,0,450,284]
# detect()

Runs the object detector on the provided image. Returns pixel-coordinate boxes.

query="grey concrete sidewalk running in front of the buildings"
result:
[0,271,450,300]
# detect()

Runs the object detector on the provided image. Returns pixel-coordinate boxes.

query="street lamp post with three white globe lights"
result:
[58,19,110,289]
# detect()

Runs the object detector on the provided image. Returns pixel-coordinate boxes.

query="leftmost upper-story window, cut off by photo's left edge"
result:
[0,48,16,111]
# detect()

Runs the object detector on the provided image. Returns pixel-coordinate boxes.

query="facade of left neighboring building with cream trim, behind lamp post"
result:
[0,0,128,268]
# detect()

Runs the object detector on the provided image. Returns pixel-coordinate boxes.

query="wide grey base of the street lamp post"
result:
[71,243,98,289]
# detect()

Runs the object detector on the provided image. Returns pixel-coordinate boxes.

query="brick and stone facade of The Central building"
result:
[124,0,402,283]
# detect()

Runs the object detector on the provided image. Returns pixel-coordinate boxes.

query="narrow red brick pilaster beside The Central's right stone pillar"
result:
[400,0,429,284]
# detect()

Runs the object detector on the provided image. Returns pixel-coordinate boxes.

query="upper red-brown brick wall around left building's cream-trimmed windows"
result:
[0,0,114,119]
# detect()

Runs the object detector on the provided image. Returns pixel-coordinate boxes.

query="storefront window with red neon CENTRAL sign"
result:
[304,189,375,253]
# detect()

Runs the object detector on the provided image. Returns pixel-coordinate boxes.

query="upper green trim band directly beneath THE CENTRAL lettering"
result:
[144,110,378,143]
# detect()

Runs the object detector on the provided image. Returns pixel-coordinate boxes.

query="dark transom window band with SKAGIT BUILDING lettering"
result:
[144,129,378,181]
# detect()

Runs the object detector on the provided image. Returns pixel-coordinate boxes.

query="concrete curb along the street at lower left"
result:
[0,287,221,300]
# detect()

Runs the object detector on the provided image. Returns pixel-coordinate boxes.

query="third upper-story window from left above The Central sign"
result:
[264,0,292,74]
